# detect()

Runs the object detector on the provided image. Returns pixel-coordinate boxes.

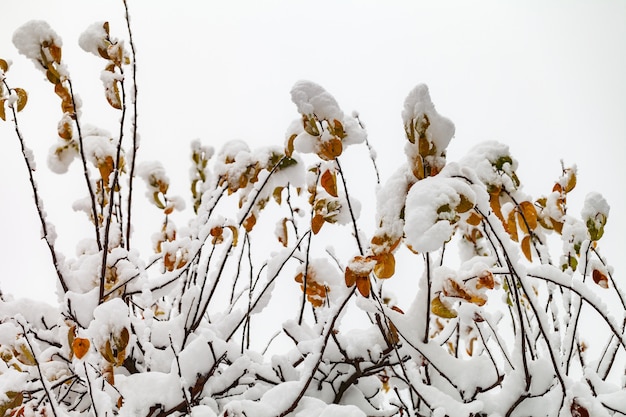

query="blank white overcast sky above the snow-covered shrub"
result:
[0,0,626,299]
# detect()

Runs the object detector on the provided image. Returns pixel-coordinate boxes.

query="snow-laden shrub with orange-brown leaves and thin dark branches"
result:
[0,15,626,417]
